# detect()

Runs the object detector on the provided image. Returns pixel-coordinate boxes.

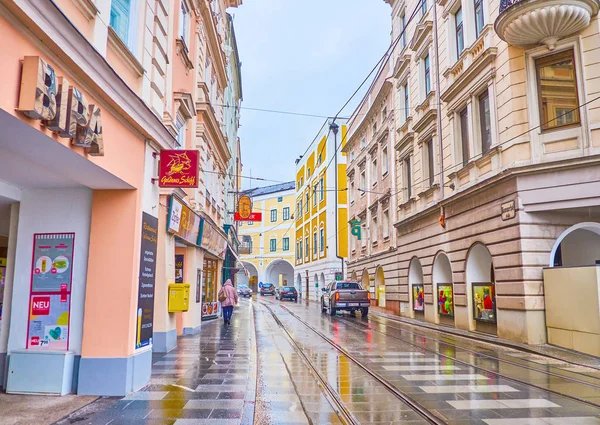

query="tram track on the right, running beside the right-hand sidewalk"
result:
[338,309,600,408]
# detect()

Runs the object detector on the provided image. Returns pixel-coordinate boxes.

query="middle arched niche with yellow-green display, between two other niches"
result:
[432,252,454,325]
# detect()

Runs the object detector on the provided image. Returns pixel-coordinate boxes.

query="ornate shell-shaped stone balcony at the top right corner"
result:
[495,0,599,50]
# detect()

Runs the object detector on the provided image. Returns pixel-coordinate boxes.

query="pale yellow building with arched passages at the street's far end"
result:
[237,182,296,291]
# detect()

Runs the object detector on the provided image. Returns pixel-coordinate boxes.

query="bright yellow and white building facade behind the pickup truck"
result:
[294,119,348,300]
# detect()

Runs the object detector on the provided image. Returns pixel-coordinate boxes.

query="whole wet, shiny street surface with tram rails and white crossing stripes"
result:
[57,297,600,425]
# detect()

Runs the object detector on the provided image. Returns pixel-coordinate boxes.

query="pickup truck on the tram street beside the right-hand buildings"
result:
[321,281,371,317]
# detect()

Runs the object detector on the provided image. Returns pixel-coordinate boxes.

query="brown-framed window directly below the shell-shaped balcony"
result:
[535,50,580,131]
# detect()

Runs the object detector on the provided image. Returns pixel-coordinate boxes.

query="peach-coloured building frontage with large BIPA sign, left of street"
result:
[0,0,241,396]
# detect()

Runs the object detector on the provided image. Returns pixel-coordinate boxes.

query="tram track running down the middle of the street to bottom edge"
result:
[260,301,448,425]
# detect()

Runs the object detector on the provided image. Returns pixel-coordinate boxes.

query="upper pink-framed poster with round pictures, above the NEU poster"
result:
[31,233,75,293]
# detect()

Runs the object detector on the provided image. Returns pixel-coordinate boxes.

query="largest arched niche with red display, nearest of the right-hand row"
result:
[466,243,498,334]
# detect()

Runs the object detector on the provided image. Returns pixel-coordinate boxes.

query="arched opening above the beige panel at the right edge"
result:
[550,222,600,267]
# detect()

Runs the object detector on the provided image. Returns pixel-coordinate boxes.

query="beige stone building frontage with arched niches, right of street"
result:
[345,0,600,354]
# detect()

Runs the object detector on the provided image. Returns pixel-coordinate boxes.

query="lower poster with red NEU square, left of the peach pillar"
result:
[27,294,71,350]
